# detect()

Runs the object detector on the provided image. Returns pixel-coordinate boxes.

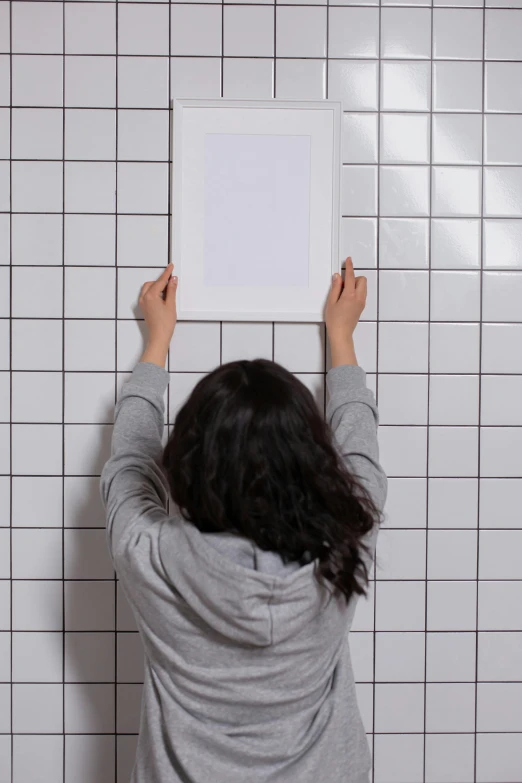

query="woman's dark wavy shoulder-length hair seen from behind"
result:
[163,359,379,600]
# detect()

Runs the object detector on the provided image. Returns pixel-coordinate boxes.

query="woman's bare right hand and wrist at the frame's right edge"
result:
[325,258,367,367]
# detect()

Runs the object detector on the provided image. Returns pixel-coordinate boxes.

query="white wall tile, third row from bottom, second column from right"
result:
[426,632,477,683]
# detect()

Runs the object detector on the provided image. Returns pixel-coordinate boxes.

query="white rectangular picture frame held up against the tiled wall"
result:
[170,98,342,322]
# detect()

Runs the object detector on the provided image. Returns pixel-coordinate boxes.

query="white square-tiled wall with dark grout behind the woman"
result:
[0,0,522,783]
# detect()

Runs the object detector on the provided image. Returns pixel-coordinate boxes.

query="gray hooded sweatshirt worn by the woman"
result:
[101,362,386,783]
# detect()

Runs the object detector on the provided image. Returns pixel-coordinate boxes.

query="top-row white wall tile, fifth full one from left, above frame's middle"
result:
[223,5,272,57]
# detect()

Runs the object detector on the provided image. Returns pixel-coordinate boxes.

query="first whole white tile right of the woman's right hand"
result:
[379,270,429,321]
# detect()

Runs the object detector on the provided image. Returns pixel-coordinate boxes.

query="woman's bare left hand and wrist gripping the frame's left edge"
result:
[139,264,178,365]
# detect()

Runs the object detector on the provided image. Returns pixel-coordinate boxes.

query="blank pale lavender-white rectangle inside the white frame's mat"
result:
[204,133,311,287]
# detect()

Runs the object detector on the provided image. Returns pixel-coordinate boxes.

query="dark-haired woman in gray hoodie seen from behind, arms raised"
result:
[101,259,386,783]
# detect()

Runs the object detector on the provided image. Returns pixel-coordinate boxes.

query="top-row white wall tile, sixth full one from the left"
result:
[276,6,324,57]
